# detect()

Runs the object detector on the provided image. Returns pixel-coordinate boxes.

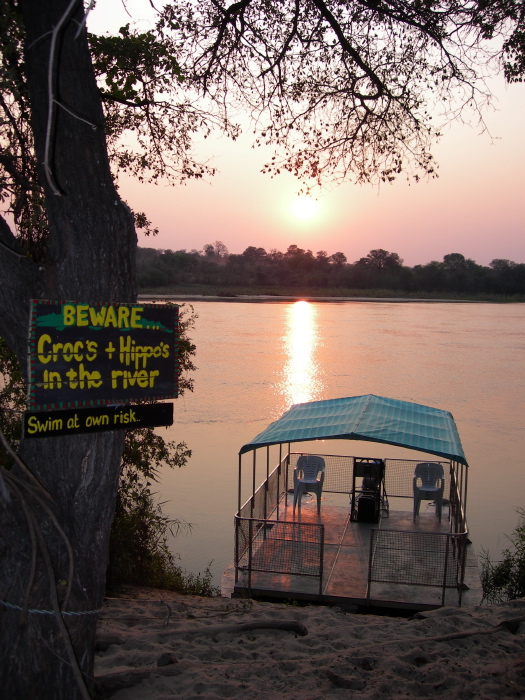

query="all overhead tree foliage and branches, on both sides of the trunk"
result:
[0,0,525,249]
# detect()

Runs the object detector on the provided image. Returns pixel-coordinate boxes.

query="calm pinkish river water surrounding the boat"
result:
[158,301,525,583]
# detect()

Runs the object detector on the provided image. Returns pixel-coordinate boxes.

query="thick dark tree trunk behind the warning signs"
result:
[0,0,136,700]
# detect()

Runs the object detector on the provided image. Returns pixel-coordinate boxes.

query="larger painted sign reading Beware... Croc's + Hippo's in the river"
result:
[28,299,179,410]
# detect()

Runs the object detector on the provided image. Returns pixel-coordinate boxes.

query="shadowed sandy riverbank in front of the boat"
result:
[95,589,525,700]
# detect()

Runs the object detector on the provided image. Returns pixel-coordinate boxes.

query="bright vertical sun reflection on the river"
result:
[279,301,322,408]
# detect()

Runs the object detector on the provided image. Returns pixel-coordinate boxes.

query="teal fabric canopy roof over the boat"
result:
[239,394,468,466]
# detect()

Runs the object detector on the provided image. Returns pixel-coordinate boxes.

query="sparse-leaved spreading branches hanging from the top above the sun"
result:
[158,0,510,189]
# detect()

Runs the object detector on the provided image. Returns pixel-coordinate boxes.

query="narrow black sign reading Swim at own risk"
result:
[24,403,173,438]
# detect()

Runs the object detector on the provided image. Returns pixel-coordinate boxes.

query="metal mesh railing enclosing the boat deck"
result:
[234,453,468,604]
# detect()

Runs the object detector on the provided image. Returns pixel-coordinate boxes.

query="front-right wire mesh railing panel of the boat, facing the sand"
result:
[369,530,466,588]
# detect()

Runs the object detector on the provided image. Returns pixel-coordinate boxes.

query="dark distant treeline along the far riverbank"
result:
[137,241,525,296]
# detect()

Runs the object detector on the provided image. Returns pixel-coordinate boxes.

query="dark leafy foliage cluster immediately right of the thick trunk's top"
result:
[89,24,237,182]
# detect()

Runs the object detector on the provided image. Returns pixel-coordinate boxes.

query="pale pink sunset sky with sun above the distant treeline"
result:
[89,0,525,266]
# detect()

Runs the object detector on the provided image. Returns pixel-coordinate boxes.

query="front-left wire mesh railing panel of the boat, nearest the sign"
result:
[236,518,324,577]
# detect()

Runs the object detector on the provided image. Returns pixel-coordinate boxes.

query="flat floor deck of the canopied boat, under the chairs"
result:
[222,495,481,610]
